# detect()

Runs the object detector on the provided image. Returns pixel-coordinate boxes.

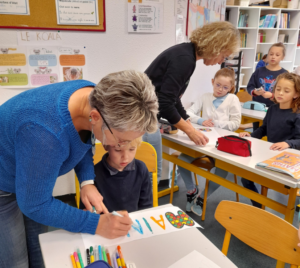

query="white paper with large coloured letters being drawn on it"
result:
[81,207,202,248]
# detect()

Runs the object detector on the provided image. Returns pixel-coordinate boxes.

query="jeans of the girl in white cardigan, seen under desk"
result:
[178,154,228,198]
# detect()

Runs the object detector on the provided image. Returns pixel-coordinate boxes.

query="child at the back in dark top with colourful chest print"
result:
[240,43,287,130]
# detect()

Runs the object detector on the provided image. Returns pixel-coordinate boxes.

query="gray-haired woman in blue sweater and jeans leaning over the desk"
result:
[0,71,158,268]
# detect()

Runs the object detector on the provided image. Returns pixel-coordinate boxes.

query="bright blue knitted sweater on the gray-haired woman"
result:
[0,80,99,234]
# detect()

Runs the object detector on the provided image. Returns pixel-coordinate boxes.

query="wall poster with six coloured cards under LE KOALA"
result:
[0,46,88,89]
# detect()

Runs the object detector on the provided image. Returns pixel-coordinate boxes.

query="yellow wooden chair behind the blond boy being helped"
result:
[75,142,158,208]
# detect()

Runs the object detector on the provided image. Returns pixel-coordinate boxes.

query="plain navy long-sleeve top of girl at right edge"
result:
[251,104,300,149]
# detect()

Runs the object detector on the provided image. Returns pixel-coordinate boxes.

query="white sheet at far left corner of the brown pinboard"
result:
[0,0,30,15]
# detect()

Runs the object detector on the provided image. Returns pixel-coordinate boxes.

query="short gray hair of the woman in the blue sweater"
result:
[89,70,158,133]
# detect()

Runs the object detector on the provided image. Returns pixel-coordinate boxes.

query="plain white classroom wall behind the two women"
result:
[0,0,220,194]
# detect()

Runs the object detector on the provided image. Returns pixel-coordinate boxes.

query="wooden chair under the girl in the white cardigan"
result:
[170,152,239,221]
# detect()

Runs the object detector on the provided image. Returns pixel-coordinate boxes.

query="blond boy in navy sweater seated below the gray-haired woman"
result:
[80,137,153,212]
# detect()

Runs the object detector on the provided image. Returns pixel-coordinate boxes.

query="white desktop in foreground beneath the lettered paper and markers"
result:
[39,204,237,268]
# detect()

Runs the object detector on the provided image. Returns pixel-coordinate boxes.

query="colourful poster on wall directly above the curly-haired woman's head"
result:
[188,0,221,36]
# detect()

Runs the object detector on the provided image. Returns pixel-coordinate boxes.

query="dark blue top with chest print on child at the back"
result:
[247,67,287,107]
